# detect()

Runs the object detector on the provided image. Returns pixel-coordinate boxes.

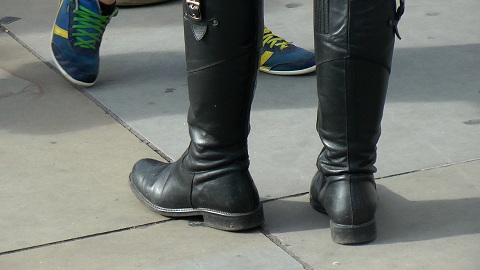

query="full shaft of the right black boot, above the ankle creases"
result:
[314,0,395,175]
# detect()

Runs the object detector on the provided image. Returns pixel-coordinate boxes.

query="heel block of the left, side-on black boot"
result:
[202,204,264,231]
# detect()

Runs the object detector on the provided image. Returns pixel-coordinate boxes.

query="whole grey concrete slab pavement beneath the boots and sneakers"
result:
[0,0,480,270]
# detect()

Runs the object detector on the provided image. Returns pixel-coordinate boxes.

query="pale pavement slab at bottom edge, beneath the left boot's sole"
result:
[0,221,304,270]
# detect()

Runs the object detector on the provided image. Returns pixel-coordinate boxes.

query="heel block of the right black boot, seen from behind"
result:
[330,219,377,245]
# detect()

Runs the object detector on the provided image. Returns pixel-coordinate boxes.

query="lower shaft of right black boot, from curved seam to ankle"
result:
[317,59,389,175]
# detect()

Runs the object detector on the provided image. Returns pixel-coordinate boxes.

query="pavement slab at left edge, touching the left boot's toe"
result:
[0,31,165,253]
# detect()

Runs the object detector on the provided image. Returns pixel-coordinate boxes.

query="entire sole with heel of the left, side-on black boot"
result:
[129,178,264,231]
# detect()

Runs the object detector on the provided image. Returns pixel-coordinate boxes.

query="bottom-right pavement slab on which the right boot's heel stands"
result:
[263,161,480,270]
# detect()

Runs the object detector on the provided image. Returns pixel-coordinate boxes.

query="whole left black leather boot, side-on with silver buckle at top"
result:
[130,0,264,231]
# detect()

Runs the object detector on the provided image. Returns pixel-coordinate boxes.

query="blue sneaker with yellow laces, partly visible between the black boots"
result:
[260,27,316,75]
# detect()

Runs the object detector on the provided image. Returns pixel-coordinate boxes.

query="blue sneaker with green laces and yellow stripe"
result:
[51,0,118,86]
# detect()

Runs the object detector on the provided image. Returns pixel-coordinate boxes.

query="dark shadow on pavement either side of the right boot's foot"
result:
[264,184,480,245]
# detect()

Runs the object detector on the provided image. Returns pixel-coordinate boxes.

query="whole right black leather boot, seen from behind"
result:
[310,0,403,244]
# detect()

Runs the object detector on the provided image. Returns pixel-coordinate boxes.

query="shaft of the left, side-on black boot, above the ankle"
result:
[184,0,263,150]
